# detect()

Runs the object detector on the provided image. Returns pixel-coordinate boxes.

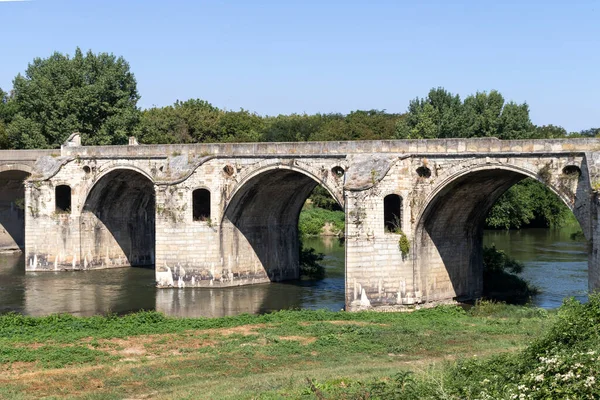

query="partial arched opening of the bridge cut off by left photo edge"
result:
[0,170,29,252]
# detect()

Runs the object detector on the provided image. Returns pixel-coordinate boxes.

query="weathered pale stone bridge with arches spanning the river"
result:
[0,135,600,310]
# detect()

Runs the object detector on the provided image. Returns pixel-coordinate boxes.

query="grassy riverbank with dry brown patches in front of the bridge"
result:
[0,303,556,399]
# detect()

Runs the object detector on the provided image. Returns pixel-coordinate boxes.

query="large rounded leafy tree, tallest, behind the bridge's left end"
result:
[7,48,139,148]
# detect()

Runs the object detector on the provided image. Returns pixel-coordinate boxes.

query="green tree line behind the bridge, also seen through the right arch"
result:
[0,48,600,227]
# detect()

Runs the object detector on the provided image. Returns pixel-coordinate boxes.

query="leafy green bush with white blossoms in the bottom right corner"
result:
[438,295,600,399]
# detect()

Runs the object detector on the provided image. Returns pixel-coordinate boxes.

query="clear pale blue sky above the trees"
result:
[0,0,600,131]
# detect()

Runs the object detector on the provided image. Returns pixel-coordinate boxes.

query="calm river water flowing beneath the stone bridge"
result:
[0,228,587,317]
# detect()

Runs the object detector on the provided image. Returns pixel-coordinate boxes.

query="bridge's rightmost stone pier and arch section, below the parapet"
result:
[346,154,598,309]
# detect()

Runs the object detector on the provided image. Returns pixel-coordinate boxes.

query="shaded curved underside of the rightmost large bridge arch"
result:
[413,165,584,301]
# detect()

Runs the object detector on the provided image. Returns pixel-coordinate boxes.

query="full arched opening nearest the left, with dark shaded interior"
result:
[81,169,155,268]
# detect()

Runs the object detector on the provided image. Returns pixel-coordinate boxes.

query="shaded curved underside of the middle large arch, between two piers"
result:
[220,166,343,283]
